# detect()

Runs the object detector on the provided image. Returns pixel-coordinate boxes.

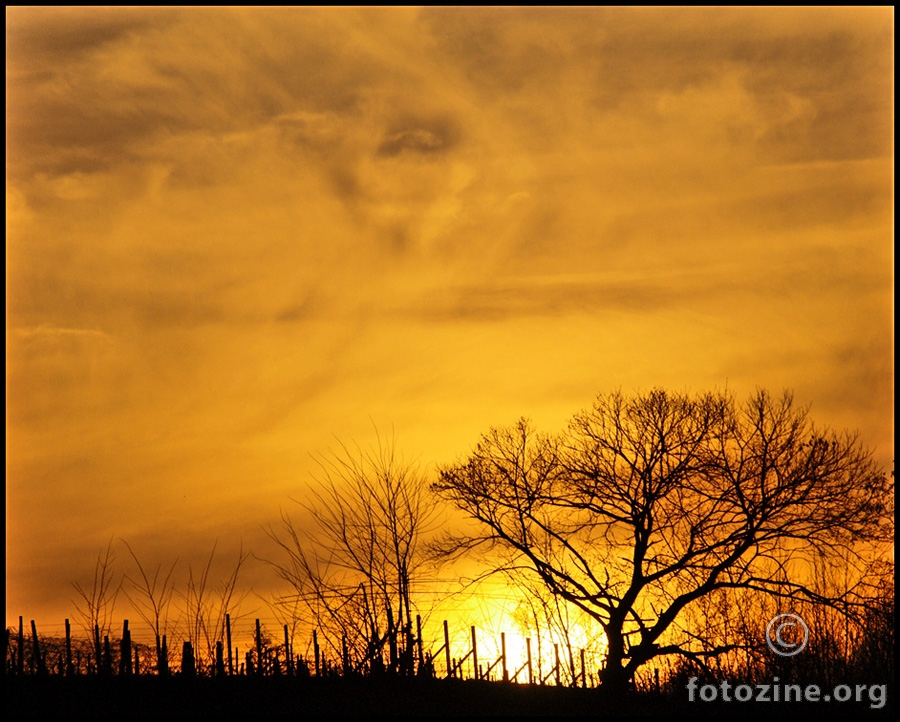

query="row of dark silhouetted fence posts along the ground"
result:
[4,614,593,687]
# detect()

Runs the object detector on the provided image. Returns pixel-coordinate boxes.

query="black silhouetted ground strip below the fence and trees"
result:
[5,677,893,720]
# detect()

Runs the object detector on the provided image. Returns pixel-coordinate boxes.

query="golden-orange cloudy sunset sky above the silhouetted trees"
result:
[6,7,894,626]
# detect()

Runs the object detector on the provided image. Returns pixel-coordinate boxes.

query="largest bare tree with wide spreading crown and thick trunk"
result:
[433,390,892,692]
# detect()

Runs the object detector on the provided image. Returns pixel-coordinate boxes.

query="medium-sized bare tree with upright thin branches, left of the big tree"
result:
[268,430,435,672]
